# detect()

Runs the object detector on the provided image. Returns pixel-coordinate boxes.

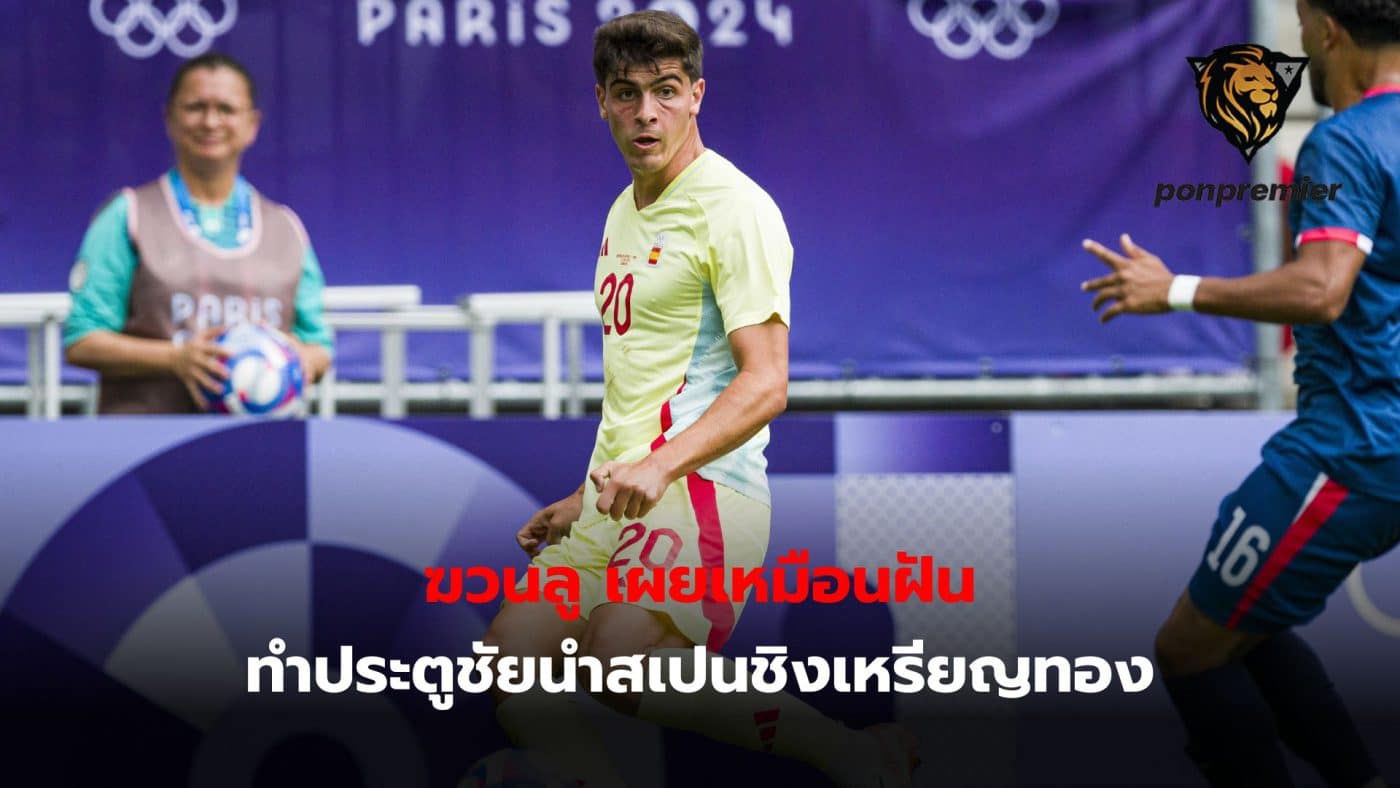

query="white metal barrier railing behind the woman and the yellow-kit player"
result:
[0,286,1259,418]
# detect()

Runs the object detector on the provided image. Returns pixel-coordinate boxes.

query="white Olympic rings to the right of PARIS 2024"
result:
[907,0,1060,60]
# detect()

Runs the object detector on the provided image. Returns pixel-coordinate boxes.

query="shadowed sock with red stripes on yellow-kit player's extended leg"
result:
[637,648,881,785]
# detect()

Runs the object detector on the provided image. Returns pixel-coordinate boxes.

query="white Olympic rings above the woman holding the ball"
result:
[88,0,238,57]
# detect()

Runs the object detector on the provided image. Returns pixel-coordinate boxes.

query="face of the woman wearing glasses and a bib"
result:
[165,69,259,172]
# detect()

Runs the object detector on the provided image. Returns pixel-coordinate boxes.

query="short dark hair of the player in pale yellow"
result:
[594,11,704,87]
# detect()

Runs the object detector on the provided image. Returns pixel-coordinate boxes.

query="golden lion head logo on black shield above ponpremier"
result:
[1186,43,1308,161]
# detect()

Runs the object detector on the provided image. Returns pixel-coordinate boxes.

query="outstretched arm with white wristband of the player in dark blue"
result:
[1082,234,1366,323]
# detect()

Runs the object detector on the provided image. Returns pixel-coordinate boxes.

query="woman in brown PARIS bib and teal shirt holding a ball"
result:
[63,53,333,413]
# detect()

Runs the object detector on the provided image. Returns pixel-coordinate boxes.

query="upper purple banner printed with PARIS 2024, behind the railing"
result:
[0,0,1268,378]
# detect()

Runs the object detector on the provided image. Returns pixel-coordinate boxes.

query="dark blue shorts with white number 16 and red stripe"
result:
[1190,462,1400,633]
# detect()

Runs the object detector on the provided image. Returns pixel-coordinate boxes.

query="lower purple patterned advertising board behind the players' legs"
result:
[0,413,1400,788]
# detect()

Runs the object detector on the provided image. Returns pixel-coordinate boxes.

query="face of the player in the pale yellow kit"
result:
[598,57,704,175]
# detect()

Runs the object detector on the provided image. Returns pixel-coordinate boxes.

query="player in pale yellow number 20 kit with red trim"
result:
[486,11,916,788]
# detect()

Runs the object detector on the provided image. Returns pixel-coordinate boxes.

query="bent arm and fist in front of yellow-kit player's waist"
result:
[589,315,788,519]
